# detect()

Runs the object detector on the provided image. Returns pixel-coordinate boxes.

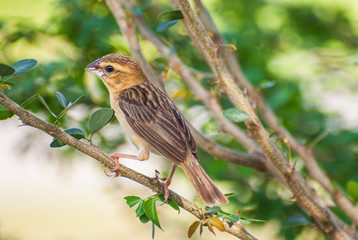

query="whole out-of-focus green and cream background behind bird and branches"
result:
[0,0,358,240]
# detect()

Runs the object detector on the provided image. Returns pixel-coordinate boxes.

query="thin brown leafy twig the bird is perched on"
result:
[0,91,255,240]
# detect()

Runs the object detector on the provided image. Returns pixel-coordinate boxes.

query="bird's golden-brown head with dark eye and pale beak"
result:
[85,54,147,92]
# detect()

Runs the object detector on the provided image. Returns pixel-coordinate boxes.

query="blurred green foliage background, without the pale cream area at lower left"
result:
[0,0,358,239]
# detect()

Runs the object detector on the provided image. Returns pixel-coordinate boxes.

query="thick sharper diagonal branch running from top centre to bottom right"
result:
[170,0,353,239]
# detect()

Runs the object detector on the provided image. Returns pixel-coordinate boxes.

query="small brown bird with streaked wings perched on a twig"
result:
[85,53,228,205]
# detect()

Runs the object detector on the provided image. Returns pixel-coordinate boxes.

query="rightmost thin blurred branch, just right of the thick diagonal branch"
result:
[194,0,358,225]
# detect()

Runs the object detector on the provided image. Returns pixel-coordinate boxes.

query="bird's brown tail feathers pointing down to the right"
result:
[180,157,229,205]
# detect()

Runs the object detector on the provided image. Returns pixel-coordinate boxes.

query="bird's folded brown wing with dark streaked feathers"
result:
[118,83,197,164]
